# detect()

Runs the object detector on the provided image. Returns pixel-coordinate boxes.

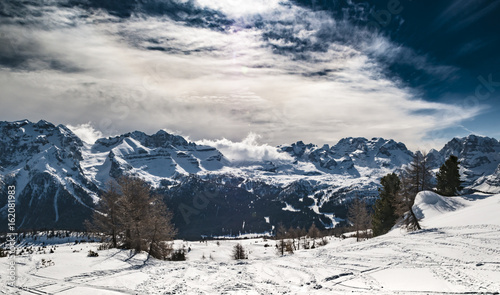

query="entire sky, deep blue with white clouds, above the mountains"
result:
[0,0,500,150]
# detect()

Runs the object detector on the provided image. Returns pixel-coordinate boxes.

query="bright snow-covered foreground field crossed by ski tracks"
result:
[0,192,500,294]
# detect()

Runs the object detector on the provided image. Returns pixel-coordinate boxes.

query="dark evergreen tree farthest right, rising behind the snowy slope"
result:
[436,155,463,196]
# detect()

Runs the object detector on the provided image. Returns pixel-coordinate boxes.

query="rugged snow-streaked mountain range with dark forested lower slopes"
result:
[0,120,500,238]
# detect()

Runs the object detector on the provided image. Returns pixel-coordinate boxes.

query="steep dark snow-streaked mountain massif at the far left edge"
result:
[0,121,98,229]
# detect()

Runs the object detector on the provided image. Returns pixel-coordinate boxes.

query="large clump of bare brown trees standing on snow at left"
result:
[88,177,176,259]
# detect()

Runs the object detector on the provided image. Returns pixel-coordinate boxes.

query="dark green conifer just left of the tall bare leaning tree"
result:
[372,173,401,236]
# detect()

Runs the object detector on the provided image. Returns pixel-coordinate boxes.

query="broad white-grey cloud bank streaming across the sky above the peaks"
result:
[0,0,481,150]
